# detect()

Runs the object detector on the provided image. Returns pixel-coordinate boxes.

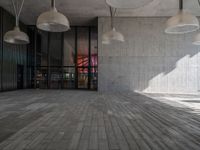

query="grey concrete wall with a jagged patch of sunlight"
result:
[98,18,200,93]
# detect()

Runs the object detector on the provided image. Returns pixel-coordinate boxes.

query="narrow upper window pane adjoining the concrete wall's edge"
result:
[90,28,98,66]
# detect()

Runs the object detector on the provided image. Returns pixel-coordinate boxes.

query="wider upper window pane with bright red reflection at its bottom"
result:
[77,28,89,67]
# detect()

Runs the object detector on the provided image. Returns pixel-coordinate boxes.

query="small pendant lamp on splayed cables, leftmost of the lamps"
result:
[4,0,29,44]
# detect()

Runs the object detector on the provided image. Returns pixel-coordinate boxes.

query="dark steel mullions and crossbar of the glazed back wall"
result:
[27,26,98,90]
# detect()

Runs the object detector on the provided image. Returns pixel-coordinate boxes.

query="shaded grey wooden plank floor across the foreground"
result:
[0,90,200,150]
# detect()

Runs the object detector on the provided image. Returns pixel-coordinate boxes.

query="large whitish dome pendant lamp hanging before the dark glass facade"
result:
[37,0,70,32]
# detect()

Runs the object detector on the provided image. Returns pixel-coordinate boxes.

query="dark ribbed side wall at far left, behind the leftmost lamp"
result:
[0,8,27,91]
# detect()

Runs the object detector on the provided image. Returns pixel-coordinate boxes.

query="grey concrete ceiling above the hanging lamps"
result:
[0,0,200,25]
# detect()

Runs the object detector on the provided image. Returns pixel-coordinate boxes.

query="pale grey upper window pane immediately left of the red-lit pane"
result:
[63,28,75,66]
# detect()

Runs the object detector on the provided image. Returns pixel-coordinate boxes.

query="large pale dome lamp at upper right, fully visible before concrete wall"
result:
[165,0,199,34]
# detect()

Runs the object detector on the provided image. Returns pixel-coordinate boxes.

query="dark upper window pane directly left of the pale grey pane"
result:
[49,33,62,66]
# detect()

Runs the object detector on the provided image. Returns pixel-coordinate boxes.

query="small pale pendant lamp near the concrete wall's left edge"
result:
[102,7,125,44]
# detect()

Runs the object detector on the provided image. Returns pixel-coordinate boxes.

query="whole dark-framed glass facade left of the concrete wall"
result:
[28,26,98,90]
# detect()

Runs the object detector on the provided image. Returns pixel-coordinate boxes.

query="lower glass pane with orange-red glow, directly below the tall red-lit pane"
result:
[78,68,88,89]
